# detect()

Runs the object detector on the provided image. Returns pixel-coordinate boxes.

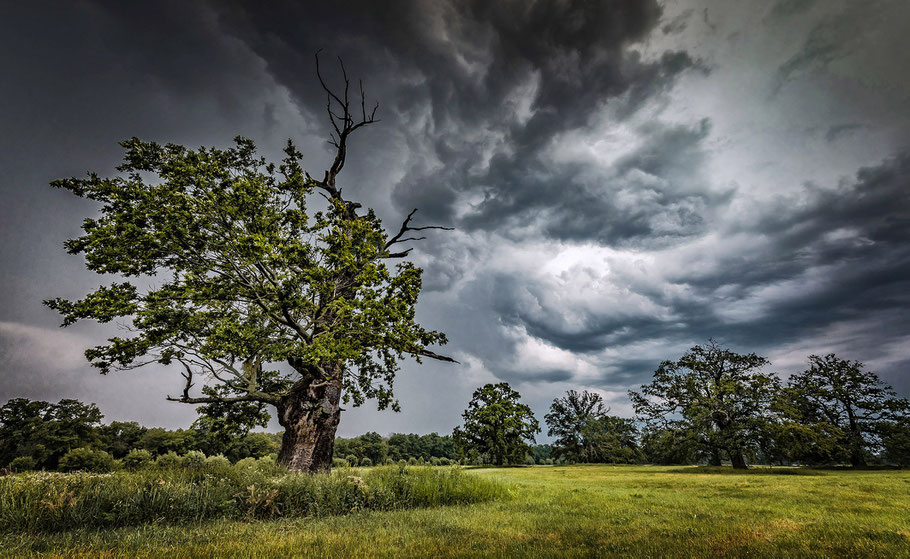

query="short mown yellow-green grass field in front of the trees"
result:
[0,466,910,557]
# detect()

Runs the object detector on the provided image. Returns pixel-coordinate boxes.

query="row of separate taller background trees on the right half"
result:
[454,341,910,469]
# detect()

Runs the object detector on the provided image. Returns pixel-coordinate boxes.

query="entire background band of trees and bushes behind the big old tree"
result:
[0,342,910,471]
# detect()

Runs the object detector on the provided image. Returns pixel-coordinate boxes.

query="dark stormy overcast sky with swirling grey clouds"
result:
[0,0,910,436]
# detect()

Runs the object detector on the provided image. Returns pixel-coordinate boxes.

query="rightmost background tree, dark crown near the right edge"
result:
[788,353,910,466]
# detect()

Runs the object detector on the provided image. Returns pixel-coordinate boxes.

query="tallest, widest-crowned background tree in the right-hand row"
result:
[629,341,779,469]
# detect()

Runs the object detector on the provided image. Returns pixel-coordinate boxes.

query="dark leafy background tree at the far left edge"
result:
[0,398,104,469]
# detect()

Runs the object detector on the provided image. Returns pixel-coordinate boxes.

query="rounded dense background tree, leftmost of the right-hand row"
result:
[453,382,540,466]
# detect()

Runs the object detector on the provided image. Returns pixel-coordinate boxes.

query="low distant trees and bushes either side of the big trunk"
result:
[0,398,457,471]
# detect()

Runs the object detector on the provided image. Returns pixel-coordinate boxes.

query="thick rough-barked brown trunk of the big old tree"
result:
[278,379,341,474]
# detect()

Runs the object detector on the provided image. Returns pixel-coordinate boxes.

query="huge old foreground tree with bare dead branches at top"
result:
[46,59,452,472]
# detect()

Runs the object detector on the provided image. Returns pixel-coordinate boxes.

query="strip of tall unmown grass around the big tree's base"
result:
[0,461,507,532]
